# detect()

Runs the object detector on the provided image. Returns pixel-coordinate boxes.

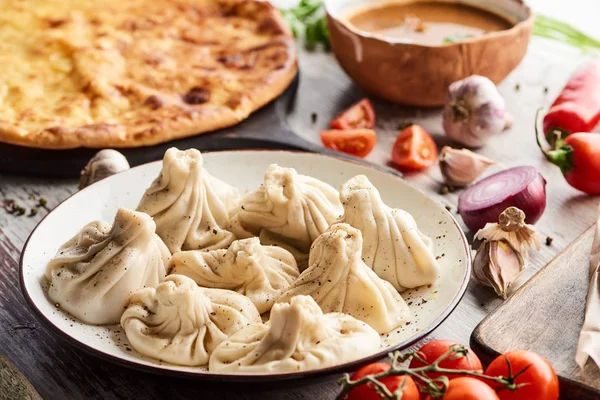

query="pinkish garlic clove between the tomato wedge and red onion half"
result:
[439,146,496,187]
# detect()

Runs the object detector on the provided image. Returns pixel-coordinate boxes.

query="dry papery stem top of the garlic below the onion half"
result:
[475,207,542,253]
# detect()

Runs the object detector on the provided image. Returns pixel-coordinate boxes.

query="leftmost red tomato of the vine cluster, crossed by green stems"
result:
[346,363,419,400]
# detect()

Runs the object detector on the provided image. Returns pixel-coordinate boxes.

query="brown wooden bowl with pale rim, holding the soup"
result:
[325,0,534,107]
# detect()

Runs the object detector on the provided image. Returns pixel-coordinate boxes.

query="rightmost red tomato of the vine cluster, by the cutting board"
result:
[485,351,559,400]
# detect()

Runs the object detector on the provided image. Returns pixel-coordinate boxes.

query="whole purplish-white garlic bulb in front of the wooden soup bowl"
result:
[443,75,506,147]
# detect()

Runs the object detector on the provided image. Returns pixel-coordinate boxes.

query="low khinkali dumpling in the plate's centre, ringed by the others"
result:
[171,237,299,313]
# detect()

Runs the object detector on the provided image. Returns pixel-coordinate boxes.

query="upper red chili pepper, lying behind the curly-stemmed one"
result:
[544,60,600,148]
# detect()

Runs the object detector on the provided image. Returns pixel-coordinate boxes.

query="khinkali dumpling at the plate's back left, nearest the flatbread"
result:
[137,147,239,253]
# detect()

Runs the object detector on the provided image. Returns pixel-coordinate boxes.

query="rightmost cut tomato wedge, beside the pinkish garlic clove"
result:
[392,125,438,170]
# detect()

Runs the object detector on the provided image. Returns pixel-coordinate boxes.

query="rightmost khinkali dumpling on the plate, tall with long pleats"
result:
[339,175,440,291]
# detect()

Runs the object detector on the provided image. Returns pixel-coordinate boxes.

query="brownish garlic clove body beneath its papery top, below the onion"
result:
[473,240,525,298]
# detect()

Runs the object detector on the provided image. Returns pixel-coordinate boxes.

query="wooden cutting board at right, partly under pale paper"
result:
[471,227,600,400]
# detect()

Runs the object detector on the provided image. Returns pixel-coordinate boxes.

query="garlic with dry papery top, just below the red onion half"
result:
[473,207,540,298]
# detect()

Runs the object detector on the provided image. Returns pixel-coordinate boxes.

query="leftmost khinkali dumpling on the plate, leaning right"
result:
[46,208,171,325]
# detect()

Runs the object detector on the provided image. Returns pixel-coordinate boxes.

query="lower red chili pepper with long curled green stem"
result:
[535,110,600,194]
